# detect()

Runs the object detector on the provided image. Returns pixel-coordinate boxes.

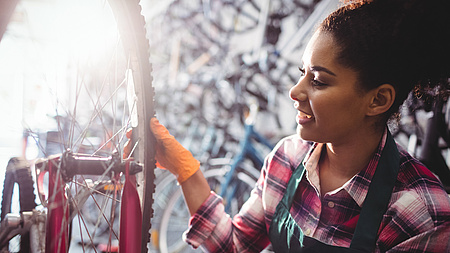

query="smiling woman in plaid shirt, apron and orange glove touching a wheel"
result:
[144,0,450,252]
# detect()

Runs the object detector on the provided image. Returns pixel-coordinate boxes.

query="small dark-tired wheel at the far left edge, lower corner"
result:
[0,158,36,252]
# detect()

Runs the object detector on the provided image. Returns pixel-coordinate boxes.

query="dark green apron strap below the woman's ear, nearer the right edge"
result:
[350,131,400,252]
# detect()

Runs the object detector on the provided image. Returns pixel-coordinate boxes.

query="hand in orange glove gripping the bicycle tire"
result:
[124,118,200,183]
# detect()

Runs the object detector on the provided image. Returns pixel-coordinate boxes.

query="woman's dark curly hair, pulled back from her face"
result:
[318,0,450,119]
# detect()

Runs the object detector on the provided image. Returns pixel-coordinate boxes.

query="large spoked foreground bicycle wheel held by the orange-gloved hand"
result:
[3,0,154,252]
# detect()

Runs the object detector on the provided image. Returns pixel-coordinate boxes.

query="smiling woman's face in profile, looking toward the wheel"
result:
[289,32,371,144]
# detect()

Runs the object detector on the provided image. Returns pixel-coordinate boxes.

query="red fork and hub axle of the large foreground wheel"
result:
[36,152,142,253]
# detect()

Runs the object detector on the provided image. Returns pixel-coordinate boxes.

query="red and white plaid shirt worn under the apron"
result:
[184,133,450,253]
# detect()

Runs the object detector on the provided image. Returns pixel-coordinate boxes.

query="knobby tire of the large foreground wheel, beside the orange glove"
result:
[109,0,156,252]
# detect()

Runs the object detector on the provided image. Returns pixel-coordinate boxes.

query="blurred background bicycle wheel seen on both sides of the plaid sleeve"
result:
[159,166,257,253]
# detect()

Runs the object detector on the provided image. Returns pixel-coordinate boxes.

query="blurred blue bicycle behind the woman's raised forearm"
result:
[156,101,273,252]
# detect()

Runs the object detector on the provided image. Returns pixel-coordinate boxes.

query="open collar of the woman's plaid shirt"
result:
[303,128,388,206]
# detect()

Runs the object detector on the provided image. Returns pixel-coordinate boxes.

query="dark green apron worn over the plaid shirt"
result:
[269,131,400,253]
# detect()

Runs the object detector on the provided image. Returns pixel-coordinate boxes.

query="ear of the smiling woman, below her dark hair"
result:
[367,84,395,116]
